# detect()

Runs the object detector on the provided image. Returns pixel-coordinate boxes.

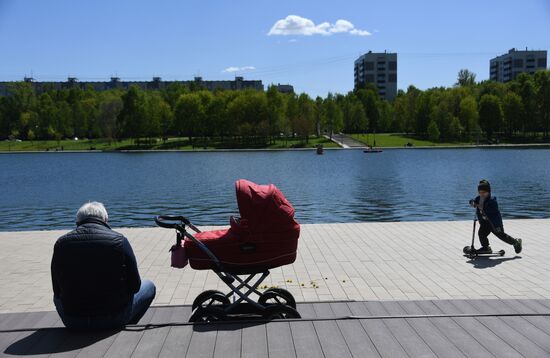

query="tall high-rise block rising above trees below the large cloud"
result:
[354,51,397,101]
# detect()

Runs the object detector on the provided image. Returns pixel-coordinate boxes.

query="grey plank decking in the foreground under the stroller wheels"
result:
[0,299,550,358]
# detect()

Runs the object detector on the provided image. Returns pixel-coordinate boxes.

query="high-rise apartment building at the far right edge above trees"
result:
[489,48,547,82]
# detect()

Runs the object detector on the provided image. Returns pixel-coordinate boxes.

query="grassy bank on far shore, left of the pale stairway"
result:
[0,136,337,152]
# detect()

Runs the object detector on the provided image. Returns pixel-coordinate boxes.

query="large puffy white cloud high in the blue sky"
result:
[267,15,371,36]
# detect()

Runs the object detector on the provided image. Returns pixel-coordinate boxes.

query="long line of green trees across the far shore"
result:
[0,70,550,143]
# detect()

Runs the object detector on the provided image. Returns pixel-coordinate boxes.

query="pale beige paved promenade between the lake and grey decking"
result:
[0,219,550,313]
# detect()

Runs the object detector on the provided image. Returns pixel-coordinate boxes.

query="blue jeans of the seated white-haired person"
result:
[53,280,156,330]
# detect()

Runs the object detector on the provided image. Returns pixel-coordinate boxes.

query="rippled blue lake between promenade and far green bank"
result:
[0,148,550,231]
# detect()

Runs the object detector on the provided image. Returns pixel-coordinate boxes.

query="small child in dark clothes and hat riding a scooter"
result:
[470,179,522,254]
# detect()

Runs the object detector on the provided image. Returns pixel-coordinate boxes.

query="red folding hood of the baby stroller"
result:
[235,179,296,233]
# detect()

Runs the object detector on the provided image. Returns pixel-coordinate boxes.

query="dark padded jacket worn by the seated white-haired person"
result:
[51,219,141,316]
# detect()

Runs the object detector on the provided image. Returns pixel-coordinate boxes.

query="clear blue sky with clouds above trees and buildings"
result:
[0,0,550,96]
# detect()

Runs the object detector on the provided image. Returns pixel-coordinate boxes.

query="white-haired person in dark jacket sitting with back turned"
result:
[51,202,156,330]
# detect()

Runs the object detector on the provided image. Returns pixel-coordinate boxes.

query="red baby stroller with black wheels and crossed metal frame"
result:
[155,179,300,322]
